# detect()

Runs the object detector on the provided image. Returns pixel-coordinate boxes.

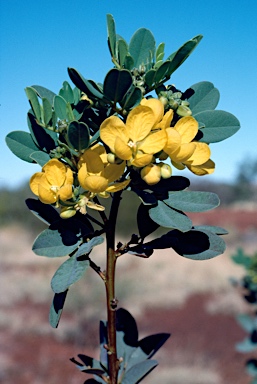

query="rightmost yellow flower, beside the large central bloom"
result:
[164,116,215,175]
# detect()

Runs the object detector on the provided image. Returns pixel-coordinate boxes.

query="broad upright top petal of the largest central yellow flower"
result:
[126,105,155,143]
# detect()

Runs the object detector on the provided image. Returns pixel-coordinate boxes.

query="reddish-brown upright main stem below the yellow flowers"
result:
[105,191,122,384]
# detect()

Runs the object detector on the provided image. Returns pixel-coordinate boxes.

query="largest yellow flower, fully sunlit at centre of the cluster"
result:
[100,99,168,168]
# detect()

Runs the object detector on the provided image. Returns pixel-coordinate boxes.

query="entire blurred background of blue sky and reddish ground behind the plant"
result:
[0,0,257,384]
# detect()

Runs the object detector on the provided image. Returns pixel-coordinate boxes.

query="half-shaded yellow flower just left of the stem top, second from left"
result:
[78,144,130,197]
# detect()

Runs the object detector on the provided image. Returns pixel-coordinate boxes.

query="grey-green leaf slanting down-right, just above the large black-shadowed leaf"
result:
[149,201,192,232]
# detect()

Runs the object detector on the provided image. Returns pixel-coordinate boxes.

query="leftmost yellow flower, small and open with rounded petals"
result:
[30,159,73,204]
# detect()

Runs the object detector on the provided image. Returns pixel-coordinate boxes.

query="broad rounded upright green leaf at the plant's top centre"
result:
[129,28,155,68]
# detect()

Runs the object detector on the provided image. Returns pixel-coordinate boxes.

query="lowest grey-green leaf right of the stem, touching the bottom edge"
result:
[122,360,158,384]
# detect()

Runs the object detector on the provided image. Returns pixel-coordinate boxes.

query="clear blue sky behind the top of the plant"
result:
[0,0,257,187]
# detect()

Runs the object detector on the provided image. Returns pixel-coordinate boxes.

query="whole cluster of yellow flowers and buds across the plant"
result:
[30,98,214,218]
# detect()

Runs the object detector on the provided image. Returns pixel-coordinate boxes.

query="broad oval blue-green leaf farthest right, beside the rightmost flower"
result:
[194,110,240,143]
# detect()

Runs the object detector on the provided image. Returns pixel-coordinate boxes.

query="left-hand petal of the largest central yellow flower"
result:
[100,116,126,152]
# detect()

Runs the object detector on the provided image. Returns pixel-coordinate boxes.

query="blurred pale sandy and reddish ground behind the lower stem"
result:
[0,211,257,384]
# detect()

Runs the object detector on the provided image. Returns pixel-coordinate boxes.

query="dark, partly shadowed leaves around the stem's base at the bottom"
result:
[71,308,170,384]
